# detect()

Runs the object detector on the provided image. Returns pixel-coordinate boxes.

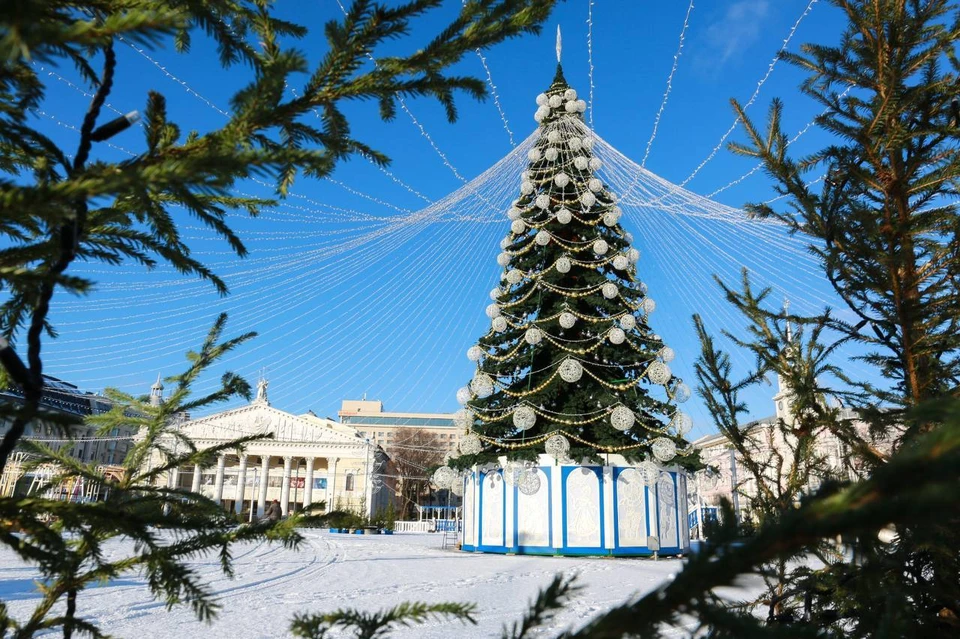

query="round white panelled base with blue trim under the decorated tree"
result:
[460,455,690,556]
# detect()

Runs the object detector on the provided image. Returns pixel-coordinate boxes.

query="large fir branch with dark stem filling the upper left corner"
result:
[0,0,556,470]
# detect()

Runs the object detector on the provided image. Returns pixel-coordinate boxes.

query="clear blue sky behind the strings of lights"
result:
[24,0,864,442]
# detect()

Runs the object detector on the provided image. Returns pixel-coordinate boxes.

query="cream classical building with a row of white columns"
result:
[154,380,393,517]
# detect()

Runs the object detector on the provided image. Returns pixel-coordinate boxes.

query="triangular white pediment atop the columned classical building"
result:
[183,402,364,444]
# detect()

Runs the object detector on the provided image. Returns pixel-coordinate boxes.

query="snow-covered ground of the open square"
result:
[0,530,744,639]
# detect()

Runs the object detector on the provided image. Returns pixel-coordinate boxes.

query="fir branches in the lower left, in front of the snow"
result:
[0,315,312,638]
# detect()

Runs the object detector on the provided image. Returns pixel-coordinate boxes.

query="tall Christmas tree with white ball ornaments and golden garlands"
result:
[437,64,691,496]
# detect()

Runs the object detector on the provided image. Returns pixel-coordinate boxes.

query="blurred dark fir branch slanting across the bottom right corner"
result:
[562,402,960,639]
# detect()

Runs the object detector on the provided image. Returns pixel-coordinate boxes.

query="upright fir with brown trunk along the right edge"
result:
[731,0,960,637]
